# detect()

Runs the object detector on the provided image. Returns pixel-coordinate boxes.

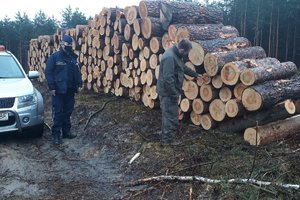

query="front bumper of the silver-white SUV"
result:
[0,104,44,133]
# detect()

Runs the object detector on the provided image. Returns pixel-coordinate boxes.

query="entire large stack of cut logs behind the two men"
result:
[28,0,300,144]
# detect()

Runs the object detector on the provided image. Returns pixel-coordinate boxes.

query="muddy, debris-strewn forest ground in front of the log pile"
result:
[0,82,300,200]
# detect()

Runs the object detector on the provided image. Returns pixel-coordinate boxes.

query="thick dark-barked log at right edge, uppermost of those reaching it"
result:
[242,76,300,111]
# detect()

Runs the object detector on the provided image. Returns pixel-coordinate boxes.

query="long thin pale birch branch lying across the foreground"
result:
[129,175,300,190]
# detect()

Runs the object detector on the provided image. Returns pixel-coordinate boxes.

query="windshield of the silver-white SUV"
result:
[0,56,24,78]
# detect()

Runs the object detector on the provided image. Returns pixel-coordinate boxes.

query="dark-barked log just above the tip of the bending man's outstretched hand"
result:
[204,46,266,76]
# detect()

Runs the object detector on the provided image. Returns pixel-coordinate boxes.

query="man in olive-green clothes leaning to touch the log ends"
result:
[156,39,201,145]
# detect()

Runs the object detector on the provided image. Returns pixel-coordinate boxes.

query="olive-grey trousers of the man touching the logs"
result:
[159,96,179,143]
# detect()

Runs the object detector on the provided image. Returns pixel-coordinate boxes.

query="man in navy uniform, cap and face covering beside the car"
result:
[45,35,82,145]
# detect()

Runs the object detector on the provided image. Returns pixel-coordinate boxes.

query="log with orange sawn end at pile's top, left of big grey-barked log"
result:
[139,0,161,18]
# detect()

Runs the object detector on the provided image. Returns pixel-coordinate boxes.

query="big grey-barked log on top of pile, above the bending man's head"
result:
[160,2,223,30]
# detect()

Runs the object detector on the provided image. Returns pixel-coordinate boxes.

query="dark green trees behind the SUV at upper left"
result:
[0,6,87,70]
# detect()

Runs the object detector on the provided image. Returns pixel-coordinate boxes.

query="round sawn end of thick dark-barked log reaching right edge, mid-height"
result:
[242,88,263,111]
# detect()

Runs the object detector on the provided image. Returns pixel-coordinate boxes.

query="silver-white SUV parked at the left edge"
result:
[0,45,44,137]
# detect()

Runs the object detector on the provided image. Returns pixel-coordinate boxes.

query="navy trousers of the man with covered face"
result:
[52,92,75,137]
